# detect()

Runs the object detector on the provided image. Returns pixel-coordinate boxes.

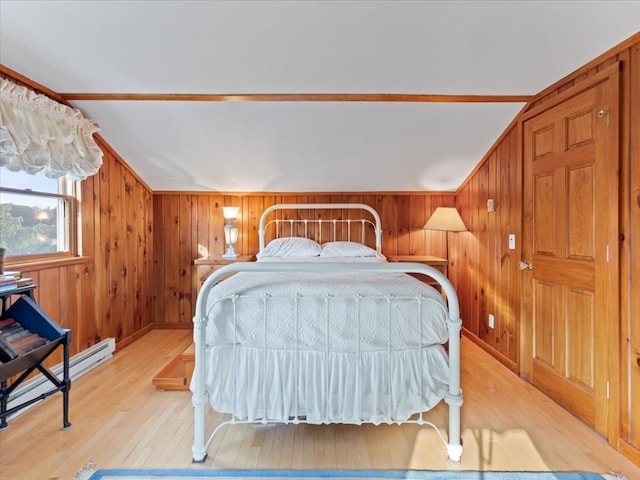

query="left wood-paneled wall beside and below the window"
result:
[8,133,153,365]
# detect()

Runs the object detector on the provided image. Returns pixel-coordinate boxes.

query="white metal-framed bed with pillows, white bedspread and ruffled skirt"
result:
[190,204,462,462]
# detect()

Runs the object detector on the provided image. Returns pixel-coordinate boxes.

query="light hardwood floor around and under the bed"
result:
[0,330,640,480]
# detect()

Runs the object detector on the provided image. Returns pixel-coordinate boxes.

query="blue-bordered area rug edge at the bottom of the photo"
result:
[78,469,626,480]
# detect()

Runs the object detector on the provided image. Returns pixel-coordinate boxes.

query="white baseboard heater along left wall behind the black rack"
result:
[7,338,116,418]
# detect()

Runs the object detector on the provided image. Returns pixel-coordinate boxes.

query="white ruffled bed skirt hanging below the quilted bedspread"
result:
[205,345,449,424]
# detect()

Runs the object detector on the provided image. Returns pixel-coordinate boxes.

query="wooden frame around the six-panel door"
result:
[517,62,621,447]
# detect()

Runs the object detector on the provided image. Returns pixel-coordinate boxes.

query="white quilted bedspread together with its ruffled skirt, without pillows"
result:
[206,272,448,423]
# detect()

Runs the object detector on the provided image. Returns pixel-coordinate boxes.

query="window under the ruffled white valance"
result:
[0,167,77,260]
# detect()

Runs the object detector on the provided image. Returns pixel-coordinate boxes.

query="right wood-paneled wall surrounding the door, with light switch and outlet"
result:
[450,34,640,464]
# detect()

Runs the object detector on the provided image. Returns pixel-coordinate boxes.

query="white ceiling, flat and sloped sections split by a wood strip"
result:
[0,0,640,192]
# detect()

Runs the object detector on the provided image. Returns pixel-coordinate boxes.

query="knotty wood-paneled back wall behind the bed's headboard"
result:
[153,192,455,328]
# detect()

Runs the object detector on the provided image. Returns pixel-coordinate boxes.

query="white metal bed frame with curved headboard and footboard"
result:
[191,204,462,463]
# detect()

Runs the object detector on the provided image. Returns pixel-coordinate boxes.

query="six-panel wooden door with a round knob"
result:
[521,65,619,438]
